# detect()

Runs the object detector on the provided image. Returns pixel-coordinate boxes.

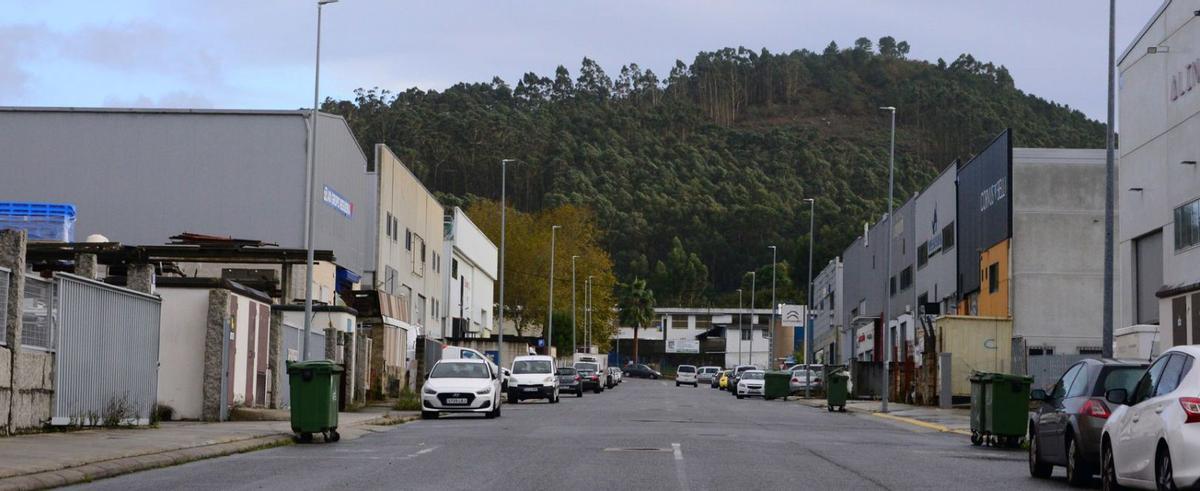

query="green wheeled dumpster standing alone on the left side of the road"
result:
[288,360,342,443]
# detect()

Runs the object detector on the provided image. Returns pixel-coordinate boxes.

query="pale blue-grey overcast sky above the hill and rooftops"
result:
[0,0,1162,120]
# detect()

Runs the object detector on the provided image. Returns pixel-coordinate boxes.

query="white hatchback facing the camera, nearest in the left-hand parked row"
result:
[421,359,500,419]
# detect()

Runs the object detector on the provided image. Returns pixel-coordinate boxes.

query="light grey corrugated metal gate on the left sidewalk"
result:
[50,274,162,425]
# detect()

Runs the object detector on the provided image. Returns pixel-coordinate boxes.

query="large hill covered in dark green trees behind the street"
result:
[324,37,1104,306]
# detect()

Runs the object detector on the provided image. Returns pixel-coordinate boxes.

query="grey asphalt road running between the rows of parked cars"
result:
[70,379,1066,490]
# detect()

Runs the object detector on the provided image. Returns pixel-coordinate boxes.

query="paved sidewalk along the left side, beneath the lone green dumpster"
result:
[0,407,418,491]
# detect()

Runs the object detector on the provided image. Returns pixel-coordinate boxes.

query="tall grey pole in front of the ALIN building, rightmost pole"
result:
[1100,0,1117,358]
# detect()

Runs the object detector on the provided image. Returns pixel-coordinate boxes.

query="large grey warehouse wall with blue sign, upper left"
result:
[0,108,374,276]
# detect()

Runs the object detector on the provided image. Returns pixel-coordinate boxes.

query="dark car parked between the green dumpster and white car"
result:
[1030,359,1148,486]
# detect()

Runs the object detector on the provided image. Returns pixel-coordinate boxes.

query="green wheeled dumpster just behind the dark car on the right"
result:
[971,373,1033,447]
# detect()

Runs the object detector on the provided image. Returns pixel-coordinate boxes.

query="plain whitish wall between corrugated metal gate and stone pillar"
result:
[158,288,209,419]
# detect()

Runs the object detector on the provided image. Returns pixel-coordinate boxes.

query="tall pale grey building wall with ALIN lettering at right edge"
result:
[1117,0,1200,347]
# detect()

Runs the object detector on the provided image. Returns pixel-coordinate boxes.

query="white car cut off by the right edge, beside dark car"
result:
[1100,346,1200,490]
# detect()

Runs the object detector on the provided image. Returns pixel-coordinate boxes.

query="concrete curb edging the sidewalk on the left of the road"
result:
[0,415,418,491]
